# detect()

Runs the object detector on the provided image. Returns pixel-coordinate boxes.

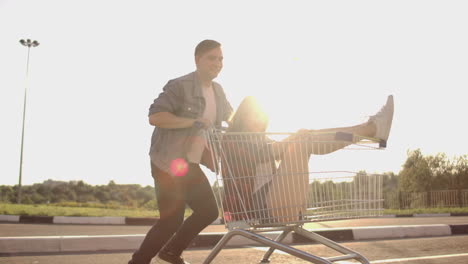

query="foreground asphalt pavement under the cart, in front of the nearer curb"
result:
[0,236,468,264]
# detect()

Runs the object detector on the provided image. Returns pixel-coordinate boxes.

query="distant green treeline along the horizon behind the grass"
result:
[0,149,468,209]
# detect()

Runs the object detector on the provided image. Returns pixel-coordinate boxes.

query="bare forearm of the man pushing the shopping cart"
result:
[149,112,211,129]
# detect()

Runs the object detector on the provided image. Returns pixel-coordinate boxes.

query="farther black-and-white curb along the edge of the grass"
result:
[0,213,468,225]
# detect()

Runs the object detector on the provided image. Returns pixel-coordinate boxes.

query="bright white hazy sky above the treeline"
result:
[0,0,468,185]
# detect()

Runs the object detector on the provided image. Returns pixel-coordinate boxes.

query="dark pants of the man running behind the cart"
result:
[129,163,218,264]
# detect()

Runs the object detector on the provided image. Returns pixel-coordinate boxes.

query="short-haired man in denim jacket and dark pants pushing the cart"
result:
[129,40,232,264]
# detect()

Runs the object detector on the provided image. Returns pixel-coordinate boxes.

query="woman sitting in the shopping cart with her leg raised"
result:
[221,96,394,224]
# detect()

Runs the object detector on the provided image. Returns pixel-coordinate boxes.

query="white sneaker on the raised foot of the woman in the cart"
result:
[369,95,394,147]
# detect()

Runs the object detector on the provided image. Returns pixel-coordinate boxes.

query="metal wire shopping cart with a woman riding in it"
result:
[204,130,385,264]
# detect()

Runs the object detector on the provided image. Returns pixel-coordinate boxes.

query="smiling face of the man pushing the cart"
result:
[195,47,223,80]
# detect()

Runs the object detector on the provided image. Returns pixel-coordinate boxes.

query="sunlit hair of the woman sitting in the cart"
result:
[227,96,269,132]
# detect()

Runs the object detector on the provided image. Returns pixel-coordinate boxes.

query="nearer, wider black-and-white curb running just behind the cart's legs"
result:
[0,224,468,256]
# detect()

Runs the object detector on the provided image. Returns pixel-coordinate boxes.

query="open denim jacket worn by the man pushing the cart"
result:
[149,72,233,174]
